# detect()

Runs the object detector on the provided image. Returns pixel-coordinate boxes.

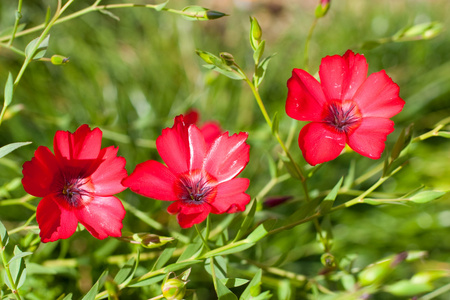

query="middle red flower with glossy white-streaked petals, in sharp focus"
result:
[122,115,250,228]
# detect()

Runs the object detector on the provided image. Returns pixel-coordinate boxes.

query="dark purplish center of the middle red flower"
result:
[176,170,217,204]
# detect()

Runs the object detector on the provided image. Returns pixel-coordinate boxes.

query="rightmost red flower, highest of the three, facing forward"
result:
[286,50,405,165]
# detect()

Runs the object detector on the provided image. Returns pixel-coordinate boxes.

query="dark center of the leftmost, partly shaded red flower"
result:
[61,178,93,207]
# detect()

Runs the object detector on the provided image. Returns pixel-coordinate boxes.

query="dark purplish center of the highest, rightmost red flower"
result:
[324,101,361,133]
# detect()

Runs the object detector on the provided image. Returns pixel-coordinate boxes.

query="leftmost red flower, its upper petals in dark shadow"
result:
[22,125,127,243]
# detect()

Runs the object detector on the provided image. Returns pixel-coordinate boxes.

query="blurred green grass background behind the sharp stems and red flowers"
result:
[0,0,450,299]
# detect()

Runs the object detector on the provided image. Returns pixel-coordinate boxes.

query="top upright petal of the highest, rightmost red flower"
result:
[319,50,368,100]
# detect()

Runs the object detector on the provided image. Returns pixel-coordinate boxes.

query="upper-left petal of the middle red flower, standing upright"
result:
[156,116,206,174]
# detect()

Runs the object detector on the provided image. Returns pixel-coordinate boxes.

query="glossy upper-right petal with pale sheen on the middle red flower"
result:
[203,132,250,183]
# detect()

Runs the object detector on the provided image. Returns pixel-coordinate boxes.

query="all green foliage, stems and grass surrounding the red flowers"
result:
[0,0,450,300]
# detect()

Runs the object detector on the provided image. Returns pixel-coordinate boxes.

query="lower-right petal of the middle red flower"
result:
[210,178,250,214]
